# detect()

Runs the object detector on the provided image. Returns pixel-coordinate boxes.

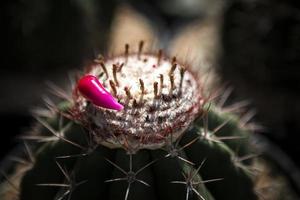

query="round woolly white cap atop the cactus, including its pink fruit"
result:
[73,45,204,152]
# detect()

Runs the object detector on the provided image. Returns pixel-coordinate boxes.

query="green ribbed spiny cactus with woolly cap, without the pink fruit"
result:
[0,42,278,200]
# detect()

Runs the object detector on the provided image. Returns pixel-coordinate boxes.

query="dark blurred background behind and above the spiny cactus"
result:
[0,0,300,176]
